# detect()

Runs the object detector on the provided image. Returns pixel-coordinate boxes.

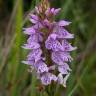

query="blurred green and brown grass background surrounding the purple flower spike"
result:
[0,0,96,96]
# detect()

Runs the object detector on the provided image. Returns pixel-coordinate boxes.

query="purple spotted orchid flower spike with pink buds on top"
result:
[22,3,76,87]
